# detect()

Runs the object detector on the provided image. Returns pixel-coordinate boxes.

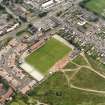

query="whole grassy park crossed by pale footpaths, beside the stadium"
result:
[9,53,105,105]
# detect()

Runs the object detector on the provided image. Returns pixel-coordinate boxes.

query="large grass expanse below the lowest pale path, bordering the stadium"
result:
[10,72,105,105]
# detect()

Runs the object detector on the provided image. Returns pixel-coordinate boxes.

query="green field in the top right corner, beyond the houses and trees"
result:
[84,0,105,17]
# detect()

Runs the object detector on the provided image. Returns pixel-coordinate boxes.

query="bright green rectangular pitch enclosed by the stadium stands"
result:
[26,38,71,74]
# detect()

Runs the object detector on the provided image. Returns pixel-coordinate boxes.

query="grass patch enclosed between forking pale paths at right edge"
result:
[72,68,105,91]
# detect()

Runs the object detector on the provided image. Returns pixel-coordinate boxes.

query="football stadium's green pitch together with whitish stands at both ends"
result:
[21,35,72,81]
